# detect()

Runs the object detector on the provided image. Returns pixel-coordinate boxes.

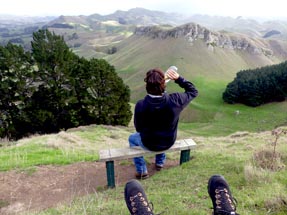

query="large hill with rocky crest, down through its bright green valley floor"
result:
[105,23,287,132]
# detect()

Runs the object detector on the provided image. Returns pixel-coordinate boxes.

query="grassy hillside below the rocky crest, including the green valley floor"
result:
[106,32,287,136]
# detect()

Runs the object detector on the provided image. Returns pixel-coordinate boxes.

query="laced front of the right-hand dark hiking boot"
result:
[214,188,239,215]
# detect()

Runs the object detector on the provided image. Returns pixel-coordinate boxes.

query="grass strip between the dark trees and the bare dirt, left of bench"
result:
[0,125,133,171]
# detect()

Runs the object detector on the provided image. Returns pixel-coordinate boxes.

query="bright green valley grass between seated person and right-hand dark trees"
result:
[179,76,287,136]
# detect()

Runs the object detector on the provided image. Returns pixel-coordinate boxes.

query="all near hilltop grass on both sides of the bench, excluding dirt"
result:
[0,113,287,215]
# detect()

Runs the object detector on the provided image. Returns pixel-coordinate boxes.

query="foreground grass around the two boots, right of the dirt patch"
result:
[16,127,287,215]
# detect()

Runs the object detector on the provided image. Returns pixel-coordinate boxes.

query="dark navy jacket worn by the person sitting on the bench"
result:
[134,77,198,151]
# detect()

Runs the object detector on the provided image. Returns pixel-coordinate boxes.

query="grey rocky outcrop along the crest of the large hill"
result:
[134,23,287,58]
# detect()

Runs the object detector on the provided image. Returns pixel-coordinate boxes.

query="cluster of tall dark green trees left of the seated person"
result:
[0,29,132,139]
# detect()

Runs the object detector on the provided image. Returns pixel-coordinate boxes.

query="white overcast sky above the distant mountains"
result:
[0,0,287,18]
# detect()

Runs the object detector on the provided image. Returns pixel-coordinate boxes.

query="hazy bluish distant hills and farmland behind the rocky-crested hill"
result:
[0,8,287,50]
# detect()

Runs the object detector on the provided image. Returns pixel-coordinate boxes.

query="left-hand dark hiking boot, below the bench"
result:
[125,179,154,215]
